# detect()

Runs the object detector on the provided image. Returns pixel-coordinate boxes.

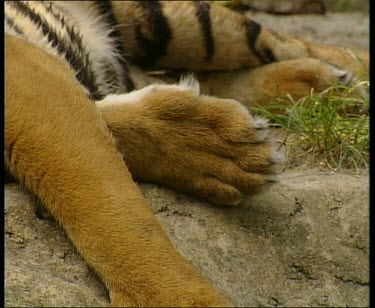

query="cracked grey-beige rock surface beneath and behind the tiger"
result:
[5,13,369,307]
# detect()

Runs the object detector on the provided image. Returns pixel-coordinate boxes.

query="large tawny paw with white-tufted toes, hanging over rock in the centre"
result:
[98,80,282,204]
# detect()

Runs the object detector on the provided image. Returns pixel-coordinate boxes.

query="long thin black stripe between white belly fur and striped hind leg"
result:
[95,0,135,91]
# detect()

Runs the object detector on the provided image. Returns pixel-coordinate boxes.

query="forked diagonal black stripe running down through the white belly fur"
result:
[8,1,104,100]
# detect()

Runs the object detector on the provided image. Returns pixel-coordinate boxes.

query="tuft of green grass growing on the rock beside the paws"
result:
[252,82,369,170]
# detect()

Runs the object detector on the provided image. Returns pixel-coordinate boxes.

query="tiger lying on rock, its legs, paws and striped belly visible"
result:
[5,1,368,307]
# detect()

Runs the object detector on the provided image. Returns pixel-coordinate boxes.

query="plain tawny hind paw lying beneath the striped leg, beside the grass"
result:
[197,58,367,111]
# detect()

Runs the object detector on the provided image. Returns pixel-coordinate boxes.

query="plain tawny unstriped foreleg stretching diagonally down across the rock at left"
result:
[5,36,228,307]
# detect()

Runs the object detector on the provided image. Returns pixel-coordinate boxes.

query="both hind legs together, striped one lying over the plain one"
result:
[112,1,369,105]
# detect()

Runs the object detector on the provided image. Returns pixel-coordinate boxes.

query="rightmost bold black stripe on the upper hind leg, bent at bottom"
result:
[245,19,276,63]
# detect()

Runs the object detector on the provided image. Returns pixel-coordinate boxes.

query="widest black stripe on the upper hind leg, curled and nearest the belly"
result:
[135,1,172,66]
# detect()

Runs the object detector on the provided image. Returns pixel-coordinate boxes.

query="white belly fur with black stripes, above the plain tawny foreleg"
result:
[5,1,134,100]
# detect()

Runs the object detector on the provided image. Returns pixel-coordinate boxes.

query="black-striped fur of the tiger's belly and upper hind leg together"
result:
[5,1,368,86]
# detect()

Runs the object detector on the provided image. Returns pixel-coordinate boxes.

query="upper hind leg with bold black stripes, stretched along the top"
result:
[112,1,368,73]
